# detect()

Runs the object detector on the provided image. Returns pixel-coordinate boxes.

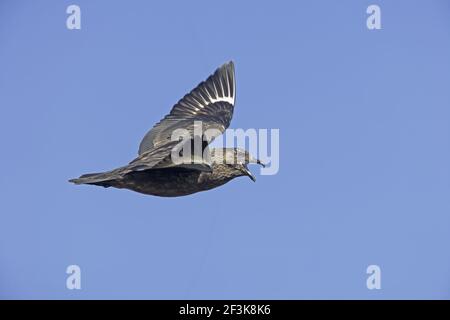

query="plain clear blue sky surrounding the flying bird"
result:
[0,0,450,299]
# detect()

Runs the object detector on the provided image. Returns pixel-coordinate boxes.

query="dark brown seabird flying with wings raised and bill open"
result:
[69,61,264,197]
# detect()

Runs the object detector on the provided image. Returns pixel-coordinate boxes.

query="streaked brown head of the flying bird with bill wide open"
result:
[211,148,265,182]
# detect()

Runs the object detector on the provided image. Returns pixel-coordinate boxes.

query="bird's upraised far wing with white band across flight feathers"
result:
[139,61,236,156]
